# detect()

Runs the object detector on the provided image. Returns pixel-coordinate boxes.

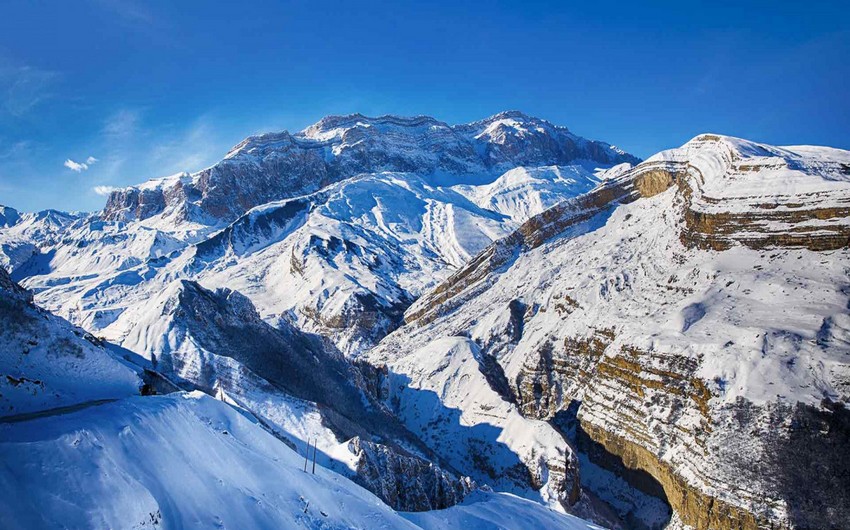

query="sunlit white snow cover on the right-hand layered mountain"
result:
[367,136,850,518]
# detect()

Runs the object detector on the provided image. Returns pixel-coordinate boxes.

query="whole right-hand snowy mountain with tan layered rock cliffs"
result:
[367,135,850,528]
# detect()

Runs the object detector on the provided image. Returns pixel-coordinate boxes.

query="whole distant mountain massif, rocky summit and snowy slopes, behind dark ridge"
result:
[0,112,636,355]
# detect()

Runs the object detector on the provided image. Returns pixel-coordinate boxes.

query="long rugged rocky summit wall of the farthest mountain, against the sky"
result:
[102,111,638,224]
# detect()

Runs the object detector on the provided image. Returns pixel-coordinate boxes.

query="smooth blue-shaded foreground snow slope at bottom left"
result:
[0,392,596,530]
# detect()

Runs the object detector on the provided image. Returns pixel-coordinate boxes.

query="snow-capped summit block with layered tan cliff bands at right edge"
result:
[668,135,850,250]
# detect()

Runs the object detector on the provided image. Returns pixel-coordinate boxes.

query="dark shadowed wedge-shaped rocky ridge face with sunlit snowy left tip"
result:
[125,280,404,436]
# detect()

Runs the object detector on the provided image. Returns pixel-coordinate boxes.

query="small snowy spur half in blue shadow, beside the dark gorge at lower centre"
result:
[368,335,571,510]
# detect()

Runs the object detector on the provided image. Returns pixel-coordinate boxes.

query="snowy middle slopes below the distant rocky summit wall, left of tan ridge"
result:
[14,166,628,354]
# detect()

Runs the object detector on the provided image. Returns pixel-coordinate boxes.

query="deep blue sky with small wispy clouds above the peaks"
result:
[0,0,850,210]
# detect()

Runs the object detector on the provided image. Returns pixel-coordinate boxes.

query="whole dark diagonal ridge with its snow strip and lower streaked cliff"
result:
[103,280,474,511]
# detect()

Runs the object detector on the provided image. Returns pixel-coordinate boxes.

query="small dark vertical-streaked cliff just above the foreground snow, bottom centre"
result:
[348,437,476,512]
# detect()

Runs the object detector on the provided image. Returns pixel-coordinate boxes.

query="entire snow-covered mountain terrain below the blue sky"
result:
[0,112,850,529]
